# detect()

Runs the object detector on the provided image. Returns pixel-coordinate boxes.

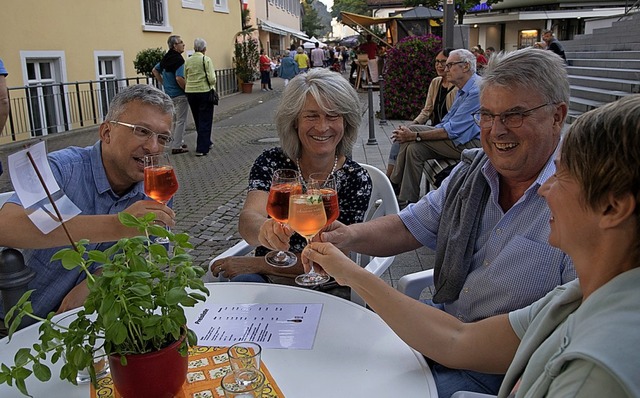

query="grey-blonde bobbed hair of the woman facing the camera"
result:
[275,68,362,159]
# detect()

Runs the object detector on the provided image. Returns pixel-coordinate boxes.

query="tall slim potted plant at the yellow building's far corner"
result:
[233,10,260,93]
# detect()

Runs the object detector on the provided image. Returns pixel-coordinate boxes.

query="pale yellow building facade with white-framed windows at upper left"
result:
[0,0,241,144]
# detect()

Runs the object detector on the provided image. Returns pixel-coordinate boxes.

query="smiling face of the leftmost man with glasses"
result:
[100,101,171,194]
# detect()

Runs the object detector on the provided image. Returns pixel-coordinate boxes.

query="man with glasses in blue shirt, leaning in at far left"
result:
[0,84,175,326]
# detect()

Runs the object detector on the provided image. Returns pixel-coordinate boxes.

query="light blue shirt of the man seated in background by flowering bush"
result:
[435,73,480,146]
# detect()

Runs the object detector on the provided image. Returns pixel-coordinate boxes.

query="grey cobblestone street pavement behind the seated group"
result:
[0,78,434,286]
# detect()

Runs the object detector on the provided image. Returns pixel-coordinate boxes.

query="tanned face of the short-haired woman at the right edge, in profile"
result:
[538,155,599,255]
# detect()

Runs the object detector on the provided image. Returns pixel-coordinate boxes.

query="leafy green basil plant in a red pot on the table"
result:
[0,213,209,398]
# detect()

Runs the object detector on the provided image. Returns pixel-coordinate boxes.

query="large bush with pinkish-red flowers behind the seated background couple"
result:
[384,35,442,120]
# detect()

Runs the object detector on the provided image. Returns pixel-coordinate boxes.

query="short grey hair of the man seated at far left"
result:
[104,84,173,122]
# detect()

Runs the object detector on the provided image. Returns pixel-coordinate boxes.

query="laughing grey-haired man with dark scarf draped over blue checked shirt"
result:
[316,49,576,397]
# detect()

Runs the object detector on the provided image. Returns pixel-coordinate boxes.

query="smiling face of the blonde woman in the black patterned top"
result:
[297,94,344,156]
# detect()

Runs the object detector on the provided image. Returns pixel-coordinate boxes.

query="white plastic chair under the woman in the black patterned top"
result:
[204,163,400,306]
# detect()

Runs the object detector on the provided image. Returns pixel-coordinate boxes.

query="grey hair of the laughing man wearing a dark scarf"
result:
[480,48,570,108]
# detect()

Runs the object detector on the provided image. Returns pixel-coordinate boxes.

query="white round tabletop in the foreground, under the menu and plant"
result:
[0,283,437,398]
